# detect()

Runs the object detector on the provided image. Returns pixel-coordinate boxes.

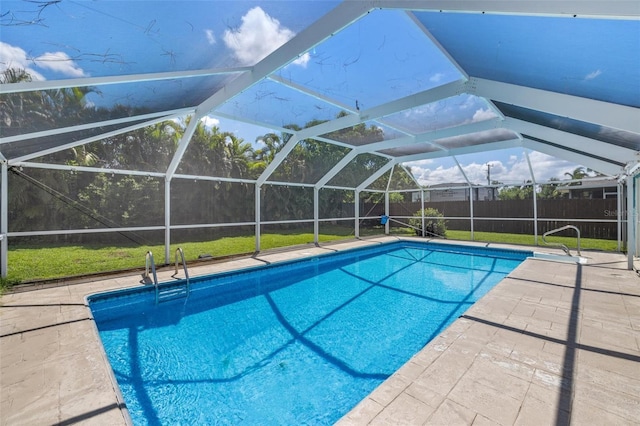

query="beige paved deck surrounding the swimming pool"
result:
[0,237,640,426]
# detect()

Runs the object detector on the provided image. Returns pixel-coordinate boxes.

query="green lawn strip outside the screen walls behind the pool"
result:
[0,225,617,293]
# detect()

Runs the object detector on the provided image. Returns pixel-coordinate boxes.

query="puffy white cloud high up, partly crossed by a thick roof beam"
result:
[222,7,300,65]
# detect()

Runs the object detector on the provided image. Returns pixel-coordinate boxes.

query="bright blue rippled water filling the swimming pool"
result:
[88,242,532,425]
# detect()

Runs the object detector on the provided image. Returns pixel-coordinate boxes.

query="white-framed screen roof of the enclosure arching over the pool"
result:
[0,0,640,187]
